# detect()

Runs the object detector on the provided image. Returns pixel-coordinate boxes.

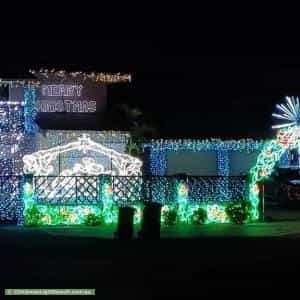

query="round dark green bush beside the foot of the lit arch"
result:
[226,201,251,224]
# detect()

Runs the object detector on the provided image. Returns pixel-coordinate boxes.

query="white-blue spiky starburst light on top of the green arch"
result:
[272,97,300,129]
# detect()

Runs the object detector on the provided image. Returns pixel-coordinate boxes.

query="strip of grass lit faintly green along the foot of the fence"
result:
[0,220,300,239]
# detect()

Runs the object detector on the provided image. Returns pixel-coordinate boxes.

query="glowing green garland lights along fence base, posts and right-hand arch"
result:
[23,126,299,225]
